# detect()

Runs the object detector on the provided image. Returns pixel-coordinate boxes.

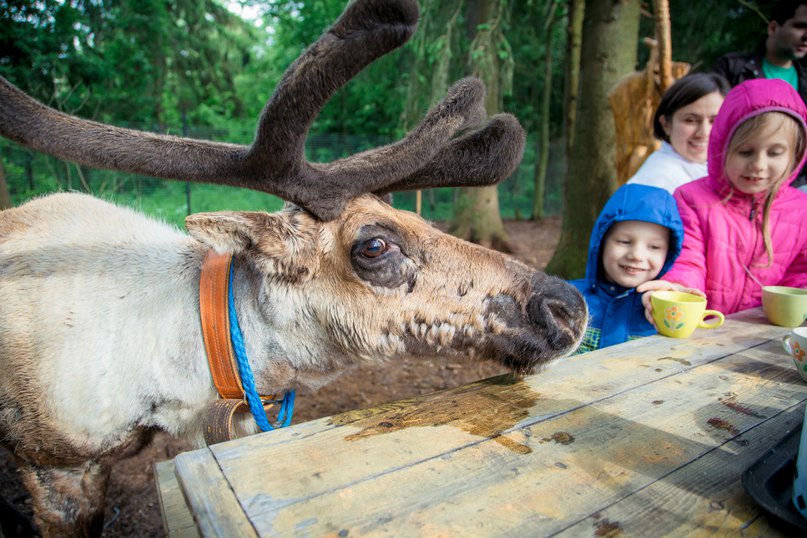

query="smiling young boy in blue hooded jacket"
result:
[572,184,684,354]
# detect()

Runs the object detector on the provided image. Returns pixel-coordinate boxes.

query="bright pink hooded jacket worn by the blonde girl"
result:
[664,79,807,314]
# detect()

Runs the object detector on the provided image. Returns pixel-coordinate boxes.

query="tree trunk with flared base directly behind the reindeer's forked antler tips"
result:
[449,0,513,252]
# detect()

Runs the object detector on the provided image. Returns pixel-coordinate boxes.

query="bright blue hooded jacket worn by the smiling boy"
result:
[571,184,684,353]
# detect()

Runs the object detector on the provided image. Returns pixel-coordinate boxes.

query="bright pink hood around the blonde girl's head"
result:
[708,78,807,193]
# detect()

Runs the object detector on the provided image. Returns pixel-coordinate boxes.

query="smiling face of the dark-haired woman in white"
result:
[659,92,723,164]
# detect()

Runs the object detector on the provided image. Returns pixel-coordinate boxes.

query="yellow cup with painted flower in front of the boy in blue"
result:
[650,291,726,338]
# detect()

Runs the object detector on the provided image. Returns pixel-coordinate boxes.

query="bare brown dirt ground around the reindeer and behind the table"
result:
[0,218,560,538]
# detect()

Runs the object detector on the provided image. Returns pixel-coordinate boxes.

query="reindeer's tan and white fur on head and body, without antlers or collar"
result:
[0,193,586,535]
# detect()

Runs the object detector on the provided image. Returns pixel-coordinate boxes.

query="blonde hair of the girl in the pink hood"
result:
[726,112,807,267]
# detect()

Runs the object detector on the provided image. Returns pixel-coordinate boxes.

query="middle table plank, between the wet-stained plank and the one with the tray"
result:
[235,336,807,536]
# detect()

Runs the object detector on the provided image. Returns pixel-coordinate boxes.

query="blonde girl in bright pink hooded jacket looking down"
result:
[637,79,807,319]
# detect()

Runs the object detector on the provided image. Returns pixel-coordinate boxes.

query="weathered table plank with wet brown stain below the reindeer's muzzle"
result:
[200,310,786,503]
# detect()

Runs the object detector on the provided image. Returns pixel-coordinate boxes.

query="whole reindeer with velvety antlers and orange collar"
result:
[0,0,587,536]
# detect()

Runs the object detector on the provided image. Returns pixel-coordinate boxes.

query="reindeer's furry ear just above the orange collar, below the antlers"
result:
[185,210,318,281]
